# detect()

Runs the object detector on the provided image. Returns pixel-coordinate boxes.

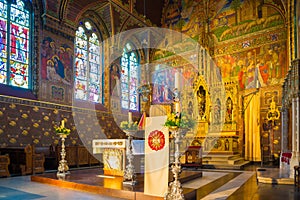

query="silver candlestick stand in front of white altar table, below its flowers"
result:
[123,130,137,185]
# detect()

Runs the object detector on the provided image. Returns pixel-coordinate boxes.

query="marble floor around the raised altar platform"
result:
[0,166,300,200]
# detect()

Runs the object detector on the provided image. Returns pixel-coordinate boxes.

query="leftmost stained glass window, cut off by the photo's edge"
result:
[0,0,31,89]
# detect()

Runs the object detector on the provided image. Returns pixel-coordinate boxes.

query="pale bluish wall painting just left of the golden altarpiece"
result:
[152,68,176,104]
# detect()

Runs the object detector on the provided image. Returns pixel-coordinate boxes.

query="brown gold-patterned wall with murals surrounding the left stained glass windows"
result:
[0,0,151,150]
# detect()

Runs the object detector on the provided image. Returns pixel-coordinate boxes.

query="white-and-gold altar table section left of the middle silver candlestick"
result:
[93,139,126,176]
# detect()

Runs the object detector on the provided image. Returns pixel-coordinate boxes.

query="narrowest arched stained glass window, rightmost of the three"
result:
[121,43,140,111]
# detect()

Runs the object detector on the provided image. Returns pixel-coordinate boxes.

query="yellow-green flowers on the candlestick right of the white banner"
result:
[164,112,195,128]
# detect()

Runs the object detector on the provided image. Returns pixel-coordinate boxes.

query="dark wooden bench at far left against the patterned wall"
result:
[0,145,45,175]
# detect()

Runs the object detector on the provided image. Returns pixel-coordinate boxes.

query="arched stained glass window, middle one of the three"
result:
[74,21,103,103]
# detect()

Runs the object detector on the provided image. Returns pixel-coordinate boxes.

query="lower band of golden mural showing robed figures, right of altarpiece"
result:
[215,42,288,89]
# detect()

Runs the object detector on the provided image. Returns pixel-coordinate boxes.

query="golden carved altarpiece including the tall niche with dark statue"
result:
[194,76,239,154]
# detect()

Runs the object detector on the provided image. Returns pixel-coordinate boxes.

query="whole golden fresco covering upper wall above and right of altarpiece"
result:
[164,0,288,89]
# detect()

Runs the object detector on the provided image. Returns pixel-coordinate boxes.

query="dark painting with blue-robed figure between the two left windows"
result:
[41,37,73,85]
